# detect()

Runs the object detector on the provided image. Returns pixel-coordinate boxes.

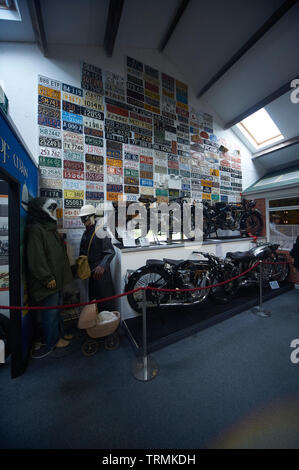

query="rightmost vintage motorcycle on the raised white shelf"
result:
[203,199,263,238]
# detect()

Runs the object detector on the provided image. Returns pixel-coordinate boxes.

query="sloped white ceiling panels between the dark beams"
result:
[0,0,299,173]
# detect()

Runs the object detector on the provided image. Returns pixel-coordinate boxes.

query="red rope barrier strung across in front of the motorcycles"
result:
[0,261,288,310]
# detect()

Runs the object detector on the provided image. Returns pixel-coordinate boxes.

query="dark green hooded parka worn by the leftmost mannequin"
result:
[26,197,73,304]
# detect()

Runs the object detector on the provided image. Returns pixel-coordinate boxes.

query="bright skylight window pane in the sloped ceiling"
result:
[237,108,284,148]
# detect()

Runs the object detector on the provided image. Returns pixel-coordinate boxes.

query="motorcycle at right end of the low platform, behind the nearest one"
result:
[225,243,289,292]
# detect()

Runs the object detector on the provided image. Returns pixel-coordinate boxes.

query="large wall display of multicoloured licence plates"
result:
[37,65,242,234]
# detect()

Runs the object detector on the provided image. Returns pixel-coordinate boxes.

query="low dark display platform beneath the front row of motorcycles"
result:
[122,283,294,356]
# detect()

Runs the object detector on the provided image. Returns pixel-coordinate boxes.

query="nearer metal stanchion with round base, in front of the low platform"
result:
[133,290,159,382]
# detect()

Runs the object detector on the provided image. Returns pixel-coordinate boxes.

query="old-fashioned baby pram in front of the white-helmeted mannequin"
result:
[78,304,120,356]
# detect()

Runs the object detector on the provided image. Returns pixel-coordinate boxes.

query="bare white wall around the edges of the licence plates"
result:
[0,43,264,189]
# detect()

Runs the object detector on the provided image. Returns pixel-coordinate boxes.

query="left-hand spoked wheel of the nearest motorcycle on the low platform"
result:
[126,266,169,313]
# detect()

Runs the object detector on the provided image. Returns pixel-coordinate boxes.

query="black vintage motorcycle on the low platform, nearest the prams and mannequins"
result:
[125,251,237,313]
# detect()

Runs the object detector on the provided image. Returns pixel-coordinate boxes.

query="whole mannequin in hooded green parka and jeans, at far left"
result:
[26,197,73,349]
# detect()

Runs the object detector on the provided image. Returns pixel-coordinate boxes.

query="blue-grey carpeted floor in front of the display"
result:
[0,290,299,449]
